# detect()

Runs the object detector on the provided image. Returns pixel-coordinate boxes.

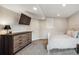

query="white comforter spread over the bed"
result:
[47,34,77,50]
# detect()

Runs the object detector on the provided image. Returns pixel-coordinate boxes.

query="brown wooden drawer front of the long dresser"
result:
[13,33,31,52]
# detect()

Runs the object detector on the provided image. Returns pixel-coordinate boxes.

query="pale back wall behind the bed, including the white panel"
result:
[40,18,68,39]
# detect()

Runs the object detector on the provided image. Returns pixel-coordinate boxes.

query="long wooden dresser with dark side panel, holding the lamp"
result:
[0,31,32,55]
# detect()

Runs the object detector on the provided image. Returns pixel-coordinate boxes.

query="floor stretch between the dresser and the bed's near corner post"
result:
[16,39,47,55]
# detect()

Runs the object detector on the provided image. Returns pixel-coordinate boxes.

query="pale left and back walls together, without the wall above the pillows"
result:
[0,7,67,40]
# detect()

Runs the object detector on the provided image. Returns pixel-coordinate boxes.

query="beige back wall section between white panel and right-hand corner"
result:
[54,18,68,33]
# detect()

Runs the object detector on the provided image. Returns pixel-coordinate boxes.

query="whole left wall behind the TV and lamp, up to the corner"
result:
[0,6,39,40]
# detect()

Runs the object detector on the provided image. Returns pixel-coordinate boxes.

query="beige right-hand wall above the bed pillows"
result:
[68,12,79,29]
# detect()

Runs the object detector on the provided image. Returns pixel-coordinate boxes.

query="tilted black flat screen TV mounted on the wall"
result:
[19,14,31,25]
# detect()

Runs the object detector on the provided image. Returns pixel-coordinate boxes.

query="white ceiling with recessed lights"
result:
[1,4,79,19]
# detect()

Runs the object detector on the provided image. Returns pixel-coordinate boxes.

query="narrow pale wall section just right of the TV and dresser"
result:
[30,19,40,40]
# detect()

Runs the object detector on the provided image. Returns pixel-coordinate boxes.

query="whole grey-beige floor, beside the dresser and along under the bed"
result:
[16,39,77,55]
